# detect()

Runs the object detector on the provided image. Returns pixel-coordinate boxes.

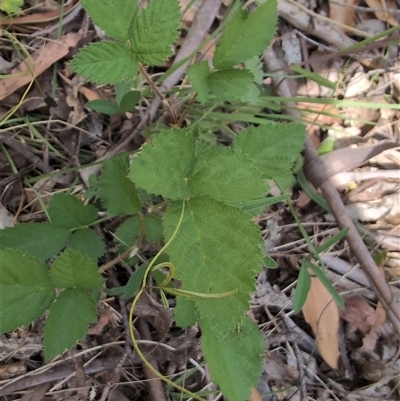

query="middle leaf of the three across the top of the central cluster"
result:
[189,146,268,205]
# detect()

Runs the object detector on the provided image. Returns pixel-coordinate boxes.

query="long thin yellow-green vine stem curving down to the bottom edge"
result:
[129,201,205,401]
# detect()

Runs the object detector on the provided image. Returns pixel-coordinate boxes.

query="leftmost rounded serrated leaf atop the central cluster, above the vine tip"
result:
[129,128,195,199]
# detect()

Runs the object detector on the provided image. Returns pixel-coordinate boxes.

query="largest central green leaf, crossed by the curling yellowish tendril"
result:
[164,196,264,330]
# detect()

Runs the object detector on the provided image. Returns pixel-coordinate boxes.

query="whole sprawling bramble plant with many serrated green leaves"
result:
[0,0,305,401]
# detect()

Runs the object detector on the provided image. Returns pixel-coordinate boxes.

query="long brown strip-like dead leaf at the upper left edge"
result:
[0,31,83,100]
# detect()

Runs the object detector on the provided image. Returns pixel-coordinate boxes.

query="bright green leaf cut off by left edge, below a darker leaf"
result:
[0,249,56,333]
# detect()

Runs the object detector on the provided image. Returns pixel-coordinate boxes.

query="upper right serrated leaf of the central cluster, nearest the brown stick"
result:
[233,122,306,178]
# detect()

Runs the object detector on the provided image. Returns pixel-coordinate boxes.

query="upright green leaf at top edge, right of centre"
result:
[213,0,278,69]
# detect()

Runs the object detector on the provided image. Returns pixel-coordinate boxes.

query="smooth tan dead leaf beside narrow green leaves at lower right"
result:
[303,271,340,369]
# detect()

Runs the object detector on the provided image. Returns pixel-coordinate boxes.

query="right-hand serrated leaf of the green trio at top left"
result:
[131,0,181,65]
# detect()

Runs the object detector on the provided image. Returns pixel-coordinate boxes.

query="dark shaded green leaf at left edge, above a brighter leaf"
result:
[0,223,71,262]
